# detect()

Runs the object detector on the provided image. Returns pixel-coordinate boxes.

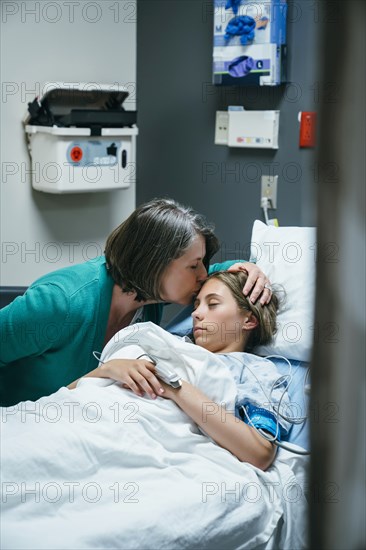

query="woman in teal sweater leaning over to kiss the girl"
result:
[0,199,271,406]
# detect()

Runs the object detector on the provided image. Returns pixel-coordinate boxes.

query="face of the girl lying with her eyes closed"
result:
[192,279,248,353]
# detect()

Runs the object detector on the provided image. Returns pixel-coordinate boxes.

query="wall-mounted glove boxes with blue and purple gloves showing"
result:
[213,0,287,86]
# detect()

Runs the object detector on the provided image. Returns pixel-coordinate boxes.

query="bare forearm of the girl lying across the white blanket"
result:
[163,381,276,470]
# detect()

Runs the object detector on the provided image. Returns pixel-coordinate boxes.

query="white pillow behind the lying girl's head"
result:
[250,220,316,361]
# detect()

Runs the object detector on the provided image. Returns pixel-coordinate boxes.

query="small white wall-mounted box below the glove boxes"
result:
[215,108,280,149]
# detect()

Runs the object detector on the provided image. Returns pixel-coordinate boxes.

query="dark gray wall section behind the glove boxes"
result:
[137,0,319,260]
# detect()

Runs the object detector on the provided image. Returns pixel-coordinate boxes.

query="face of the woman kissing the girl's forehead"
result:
[160,235,207,305]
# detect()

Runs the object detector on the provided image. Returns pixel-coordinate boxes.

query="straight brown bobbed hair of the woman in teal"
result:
[105,199,219,301]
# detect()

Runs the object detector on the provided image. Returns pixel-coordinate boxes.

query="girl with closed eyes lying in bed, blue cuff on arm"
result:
[68,272,286,470]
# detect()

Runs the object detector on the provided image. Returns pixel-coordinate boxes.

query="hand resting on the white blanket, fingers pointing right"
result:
[100,359,164,399]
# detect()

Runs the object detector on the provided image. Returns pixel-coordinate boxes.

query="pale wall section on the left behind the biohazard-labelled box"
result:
[0,0,137,286]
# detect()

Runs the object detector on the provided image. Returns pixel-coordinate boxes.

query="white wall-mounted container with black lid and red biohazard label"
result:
[23,83,138,193]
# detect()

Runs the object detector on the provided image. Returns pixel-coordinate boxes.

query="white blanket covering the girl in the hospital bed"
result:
[0,323,306,550]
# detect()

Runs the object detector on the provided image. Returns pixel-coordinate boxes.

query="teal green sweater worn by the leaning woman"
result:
[0,256,243,406]
